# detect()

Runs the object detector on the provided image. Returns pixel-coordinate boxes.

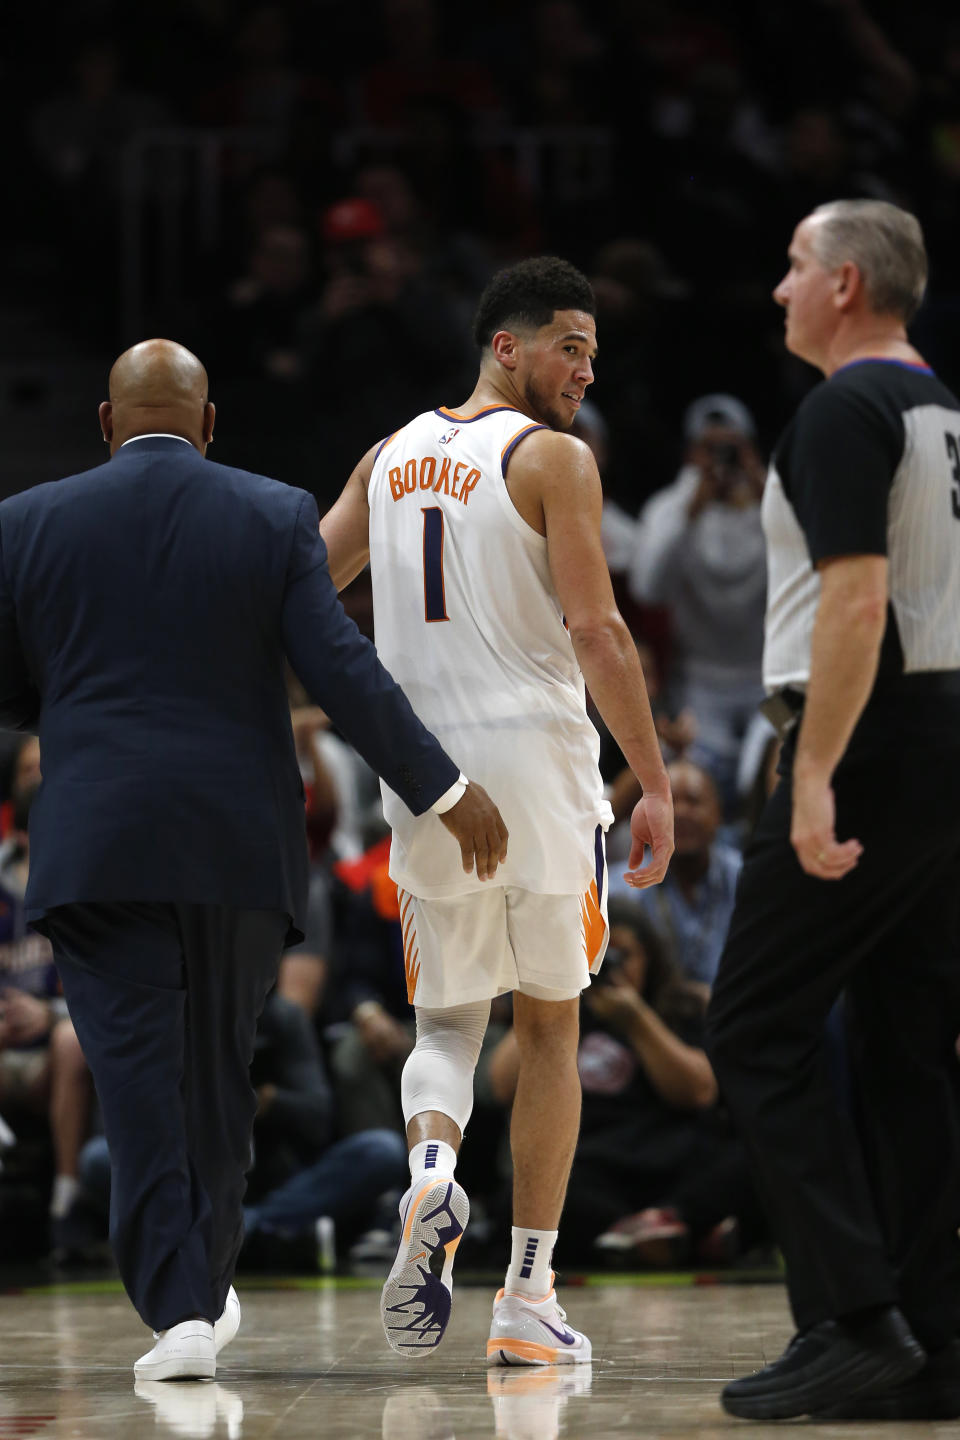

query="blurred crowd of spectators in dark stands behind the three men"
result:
[0,0,960,1284]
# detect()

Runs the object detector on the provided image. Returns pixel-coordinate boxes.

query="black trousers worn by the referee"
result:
[708,727,960,1348]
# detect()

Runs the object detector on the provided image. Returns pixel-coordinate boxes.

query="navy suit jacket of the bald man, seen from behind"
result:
[0,436,458,942]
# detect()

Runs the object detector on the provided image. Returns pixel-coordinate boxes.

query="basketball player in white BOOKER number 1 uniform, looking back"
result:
[321,258,674,1365]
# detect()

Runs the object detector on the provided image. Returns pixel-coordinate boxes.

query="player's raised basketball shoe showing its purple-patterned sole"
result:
[380,1175,471,1355]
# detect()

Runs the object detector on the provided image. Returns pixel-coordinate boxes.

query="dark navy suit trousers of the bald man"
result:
[43,903,289,1331]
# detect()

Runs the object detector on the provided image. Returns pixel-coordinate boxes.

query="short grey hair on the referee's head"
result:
[813,200,927,323]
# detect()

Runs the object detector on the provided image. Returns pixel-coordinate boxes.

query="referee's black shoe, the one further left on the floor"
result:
[720,1305,927,1420]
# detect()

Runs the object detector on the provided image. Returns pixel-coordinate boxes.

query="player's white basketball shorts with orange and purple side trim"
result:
[399,831,609,1009]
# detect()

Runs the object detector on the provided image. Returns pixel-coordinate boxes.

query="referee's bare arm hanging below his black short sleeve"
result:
[790,554,888,880]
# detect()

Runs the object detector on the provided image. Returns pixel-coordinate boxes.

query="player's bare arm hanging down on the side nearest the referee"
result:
[508,431,674,886]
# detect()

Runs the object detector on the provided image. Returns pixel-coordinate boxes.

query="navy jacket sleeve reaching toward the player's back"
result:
[282,495,459,815]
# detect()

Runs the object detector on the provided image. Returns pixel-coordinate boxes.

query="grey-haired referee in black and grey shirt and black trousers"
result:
[708,200,960,1420]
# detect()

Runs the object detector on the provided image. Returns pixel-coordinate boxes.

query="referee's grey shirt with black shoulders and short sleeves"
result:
[761,360,960,693]
